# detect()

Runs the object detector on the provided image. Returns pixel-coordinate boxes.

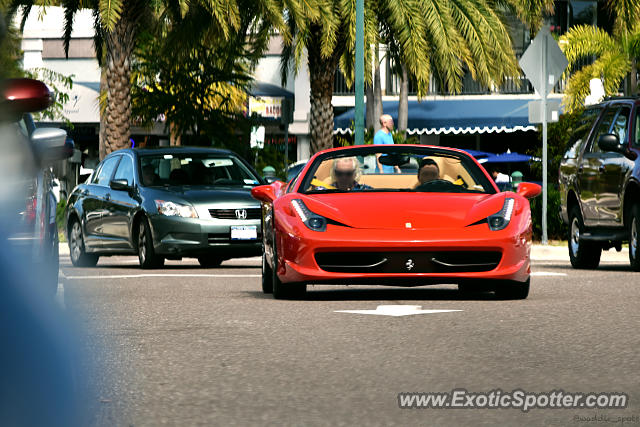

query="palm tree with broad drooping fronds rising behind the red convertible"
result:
[282,0,536,152]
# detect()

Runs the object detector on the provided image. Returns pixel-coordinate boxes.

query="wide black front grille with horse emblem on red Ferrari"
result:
[315,251,502,273]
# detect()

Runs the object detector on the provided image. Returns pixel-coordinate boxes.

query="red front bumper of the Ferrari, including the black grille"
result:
[278,224,531,286]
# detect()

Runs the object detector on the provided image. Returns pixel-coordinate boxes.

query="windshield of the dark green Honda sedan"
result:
[140,152,259,187]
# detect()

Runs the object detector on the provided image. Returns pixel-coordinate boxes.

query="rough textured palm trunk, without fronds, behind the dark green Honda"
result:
[105,17,136,154]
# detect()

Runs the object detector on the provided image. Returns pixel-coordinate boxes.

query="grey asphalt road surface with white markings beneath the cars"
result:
[57,252,640,426]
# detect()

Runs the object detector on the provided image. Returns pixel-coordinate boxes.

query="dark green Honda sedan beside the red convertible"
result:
[66,147,264,268]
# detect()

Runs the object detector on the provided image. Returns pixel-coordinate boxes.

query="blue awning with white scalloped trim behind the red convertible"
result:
[334,98,537,135]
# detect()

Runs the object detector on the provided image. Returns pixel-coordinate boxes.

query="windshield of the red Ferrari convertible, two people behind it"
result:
[299,145,496,194]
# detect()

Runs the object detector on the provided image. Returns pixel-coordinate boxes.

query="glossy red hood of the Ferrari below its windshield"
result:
[304,193,505,229]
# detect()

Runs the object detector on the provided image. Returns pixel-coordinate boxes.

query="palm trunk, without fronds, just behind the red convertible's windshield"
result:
[307,26,339,155]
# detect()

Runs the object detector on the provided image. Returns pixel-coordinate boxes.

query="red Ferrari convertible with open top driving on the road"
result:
[251,145,540,299]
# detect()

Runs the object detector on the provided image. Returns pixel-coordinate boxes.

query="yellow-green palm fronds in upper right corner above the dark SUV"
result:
[560,0,640,112]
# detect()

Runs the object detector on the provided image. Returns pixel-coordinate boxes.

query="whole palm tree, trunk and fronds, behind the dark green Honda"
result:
[9,0,278,154]
